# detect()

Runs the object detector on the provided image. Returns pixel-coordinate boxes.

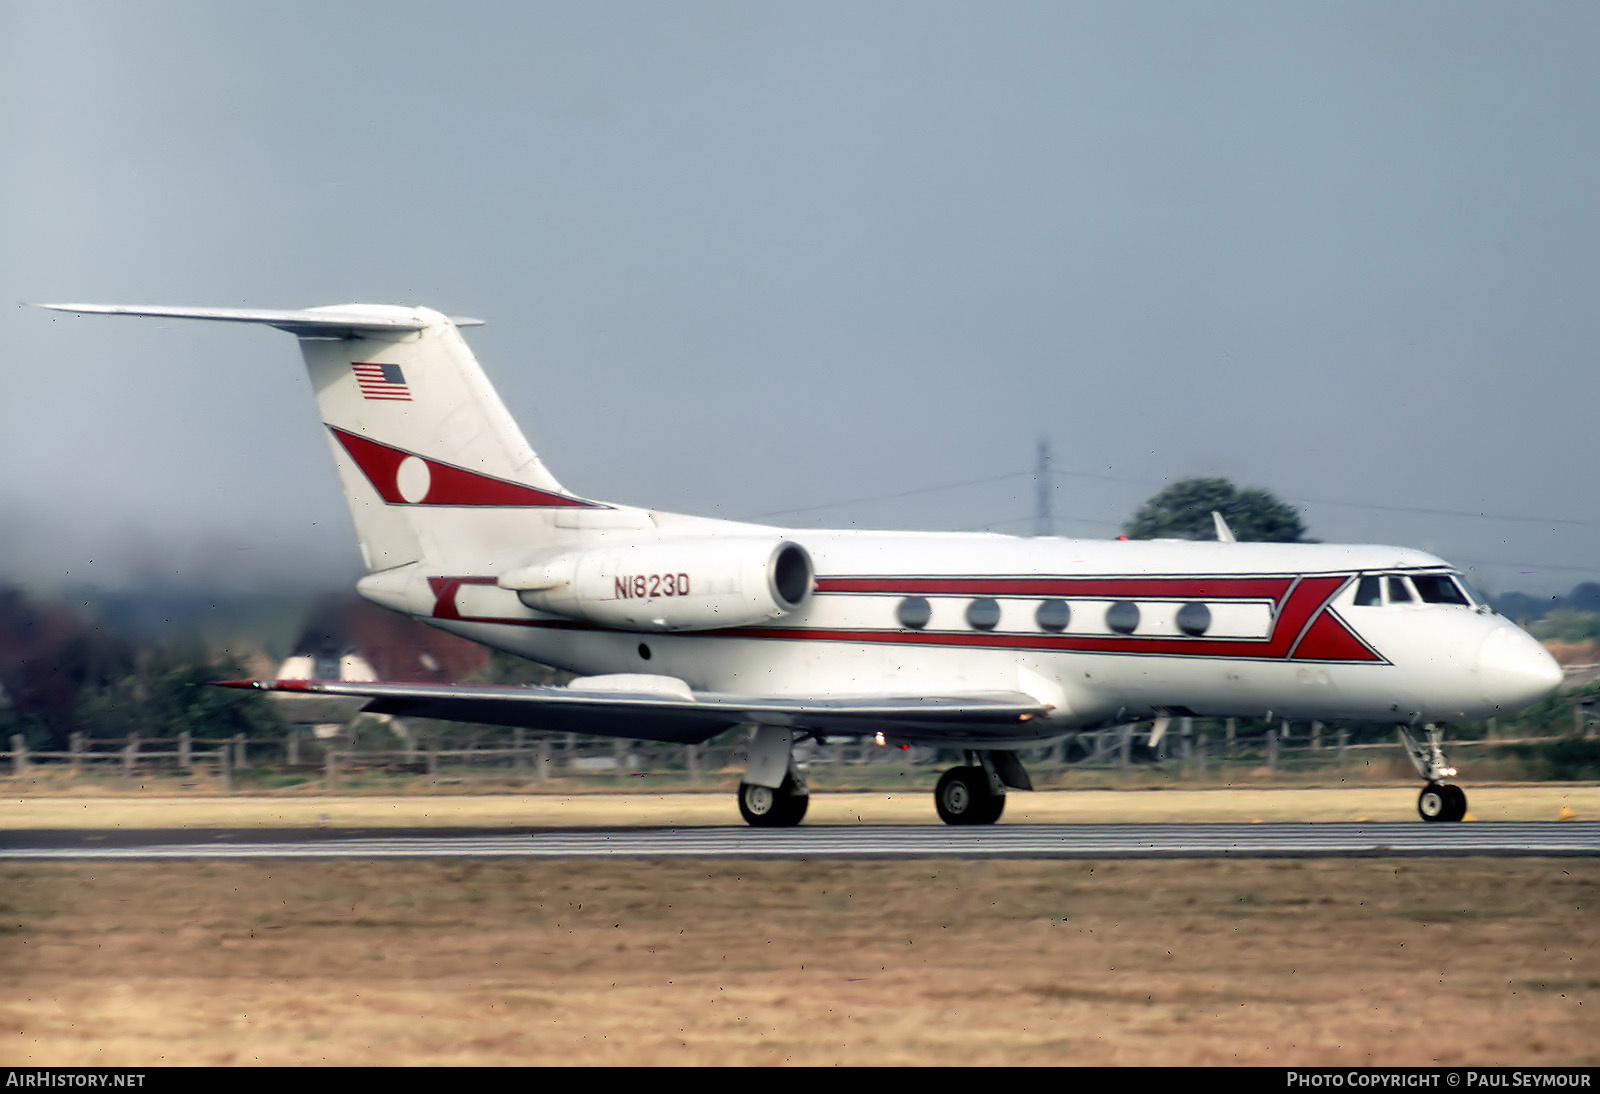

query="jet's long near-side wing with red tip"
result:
[221,680,1050,744]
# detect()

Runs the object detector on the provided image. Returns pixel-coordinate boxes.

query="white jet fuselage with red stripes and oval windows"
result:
[363,529,1560,745]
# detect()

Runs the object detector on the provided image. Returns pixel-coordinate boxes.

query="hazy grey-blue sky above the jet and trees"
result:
[0,0,1600,590]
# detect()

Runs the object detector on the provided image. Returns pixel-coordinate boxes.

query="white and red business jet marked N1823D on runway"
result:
[45,304,1562,825]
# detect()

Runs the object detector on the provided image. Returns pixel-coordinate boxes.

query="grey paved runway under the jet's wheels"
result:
[0,822,1600,862]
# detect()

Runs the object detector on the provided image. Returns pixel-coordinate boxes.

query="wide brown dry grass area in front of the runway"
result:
[0,859,1600,1067]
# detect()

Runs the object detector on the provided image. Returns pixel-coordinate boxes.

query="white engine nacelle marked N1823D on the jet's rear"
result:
[499,536,816,630]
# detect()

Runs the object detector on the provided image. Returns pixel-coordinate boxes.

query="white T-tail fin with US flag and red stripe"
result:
[43,304,611,573]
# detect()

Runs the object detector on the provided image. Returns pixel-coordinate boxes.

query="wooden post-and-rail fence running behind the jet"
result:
[0,718,1587,789]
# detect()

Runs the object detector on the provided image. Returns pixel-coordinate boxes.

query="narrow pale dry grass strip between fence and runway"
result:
[0,784,1600,828]
